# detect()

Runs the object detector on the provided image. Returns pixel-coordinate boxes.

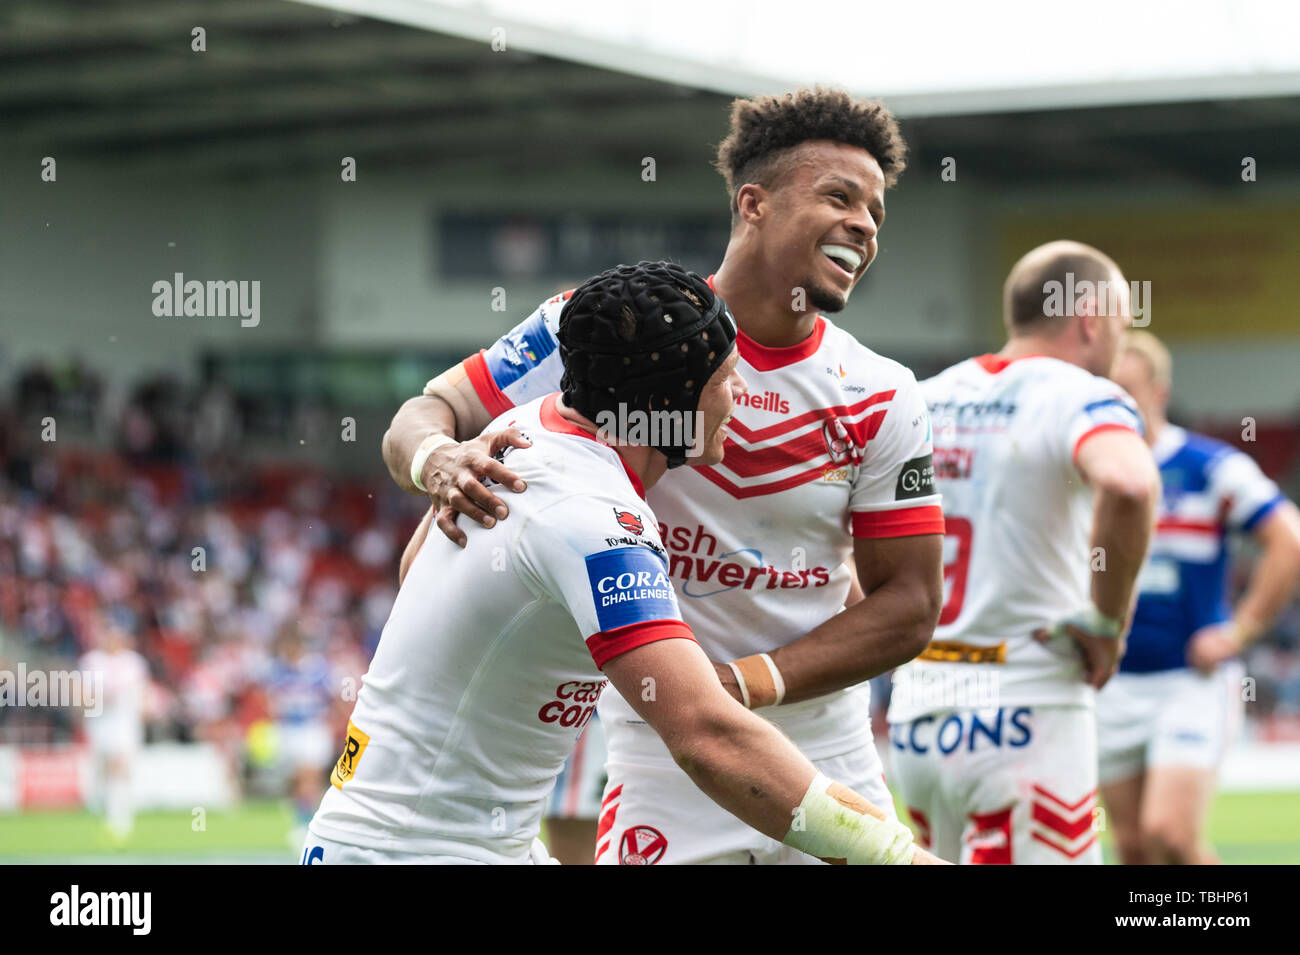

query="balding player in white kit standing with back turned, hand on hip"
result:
[889,242,1158,864]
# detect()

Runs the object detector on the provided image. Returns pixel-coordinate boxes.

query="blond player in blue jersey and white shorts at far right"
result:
[1097,330,1300,864]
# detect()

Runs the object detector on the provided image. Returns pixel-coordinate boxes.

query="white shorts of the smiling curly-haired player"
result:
[595,728,896,865]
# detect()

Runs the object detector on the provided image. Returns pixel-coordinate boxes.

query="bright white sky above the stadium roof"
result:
[300,0,1300,116]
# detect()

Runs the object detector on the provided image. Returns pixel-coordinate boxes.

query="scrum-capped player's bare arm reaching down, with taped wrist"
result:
[603,639,943,865]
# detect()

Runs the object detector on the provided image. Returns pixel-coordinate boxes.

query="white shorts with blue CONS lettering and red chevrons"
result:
[889,706,1101,865]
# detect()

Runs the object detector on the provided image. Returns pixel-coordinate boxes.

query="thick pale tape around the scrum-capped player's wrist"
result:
[783,773,917,865]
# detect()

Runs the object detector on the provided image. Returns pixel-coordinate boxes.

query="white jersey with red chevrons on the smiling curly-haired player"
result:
[452,277,944,760]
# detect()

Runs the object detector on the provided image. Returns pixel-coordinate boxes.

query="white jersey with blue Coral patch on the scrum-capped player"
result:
[311,395,690,863]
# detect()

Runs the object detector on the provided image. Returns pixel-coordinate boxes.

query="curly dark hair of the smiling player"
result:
[714,87,907,216]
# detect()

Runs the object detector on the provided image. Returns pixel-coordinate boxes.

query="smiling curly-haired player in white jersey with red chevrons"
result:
[384,90,944,864]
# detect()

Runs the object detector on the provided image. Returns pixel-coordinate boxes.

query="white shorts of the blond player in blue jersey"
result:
[1097,660,1245,783]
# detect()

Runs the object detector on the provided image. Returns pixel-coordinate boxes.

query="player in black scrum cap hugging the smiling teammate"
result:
[303,262,937,864]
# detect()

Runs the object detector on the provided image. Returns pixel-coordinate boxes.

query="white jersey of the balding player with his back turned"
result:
[889,355,1141,722]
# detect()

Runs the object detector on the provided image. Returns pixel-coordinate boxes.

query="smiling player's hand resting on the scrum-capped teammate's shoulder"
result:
[420,427,530,547]
